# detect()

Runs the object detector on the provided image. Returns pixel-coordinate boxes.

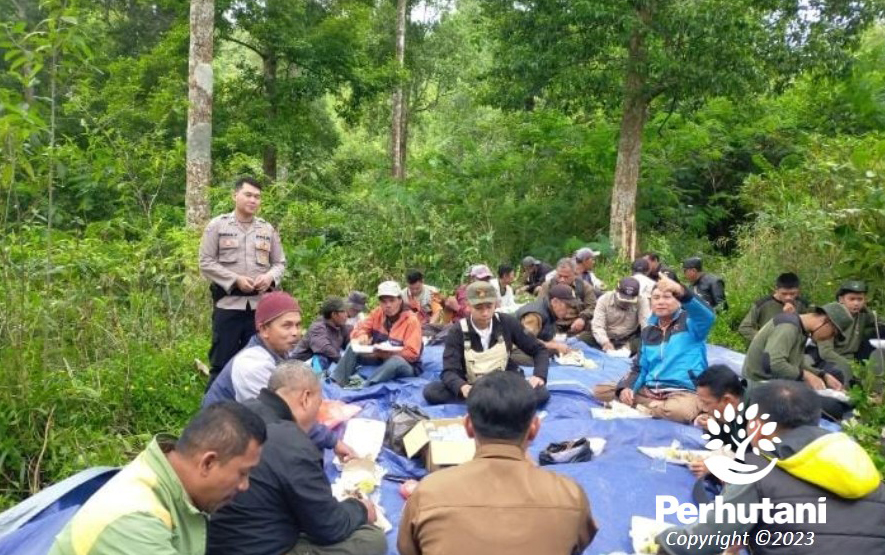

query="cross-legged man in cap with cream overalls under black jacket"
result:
[424,281,550,405]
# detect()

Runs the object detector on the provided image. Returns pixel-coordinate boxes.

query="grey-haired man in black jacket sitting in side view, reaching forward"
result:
[207,360,387,555]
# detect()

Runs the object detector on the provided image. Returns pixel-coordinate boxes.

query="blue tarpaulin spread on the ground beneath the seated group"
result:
[0,343,743,555]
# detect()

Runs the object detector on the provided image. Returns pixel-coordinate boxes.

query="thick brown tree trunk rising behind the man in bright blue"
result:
[609,25,649,260]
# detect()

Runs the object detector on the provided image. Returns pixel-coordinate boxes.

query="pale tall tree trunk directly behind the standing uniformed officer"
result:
[184,0,215,228]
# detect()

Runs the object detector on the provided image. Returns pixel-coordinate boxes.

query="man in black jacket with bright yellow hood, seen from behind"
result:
[656,380,885,555]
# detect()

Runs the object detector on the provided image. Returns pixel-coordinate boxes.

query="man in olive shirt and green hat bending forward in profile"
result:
[743,303,851,390]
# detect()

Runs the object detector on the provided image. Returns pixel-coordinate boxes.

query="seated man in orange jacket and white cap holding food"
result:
[332,281,423,386]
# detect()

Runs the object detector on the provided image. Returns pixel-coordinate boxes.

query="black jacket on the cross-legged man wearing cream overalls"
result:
[440,314,550,397]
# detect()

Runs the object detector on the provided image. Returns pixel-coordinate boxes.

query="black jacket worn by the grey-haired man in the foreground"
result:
[206,389,367,555]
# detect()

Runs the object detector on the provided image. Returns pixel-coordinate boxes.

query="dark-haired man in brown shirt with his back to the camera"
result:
[397,372,597,555]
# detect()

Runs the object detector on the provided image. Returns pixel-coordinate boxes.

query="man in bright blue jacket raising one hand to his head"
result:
[594,277,716,423]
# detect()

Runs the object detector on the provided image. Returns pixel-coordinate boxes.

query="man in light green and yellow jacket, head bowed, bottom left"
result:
[49,401,267,555]
